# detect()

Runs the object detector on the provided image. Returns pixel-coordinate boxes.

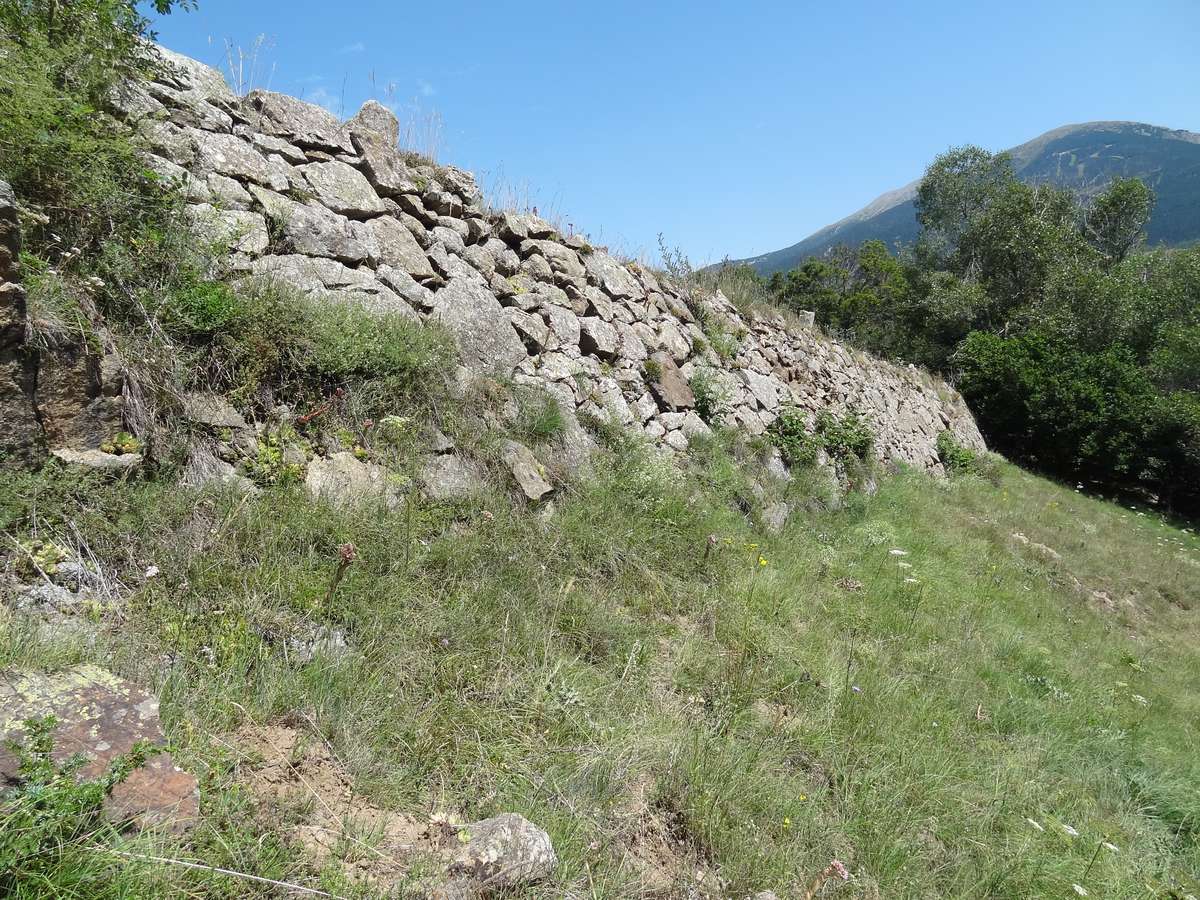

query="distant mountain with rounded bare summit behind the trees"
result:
[739,122,1200,275]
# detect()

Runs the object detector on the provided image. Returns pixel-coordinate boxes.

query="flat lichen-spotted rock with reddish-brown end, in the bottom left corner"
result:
[0,665,200,833]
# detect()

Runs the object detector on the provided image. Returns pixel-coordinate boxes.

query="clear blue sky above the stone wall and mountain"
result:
[147,0,1200,263]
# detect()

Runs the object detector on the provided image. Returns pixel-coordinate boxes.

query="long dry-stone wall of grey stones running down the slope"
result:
[116,44,983,469]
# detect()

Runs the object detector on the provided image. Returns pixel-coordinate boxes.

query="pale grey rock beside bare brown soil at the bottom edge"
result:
[449,812,558,890]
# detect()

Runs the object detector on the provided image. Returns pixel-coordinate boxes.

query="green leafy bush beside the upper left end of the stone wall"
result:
[0,0,191,260]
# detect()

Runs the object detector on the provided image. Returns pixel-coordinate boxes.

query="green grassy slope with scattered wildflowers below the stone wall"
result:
[0,434,1200,898]
